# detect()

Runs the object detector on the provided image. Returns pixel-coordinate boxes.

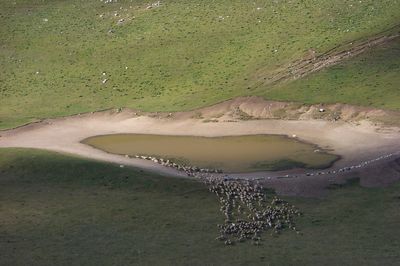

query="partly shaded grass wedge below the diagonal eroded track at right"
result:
[259,38,400,110]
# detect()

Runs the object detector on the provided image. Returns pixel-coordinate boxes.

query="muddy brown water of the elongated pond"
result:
[83,134,337,172]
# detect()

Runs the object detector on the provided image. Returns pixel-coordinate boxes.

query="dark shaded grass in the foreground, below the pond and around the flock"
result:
[0,149,400,265]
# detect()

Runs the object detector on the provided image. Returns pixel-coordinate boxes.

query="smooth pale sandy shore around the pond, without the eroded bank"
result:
[0,107,400,194]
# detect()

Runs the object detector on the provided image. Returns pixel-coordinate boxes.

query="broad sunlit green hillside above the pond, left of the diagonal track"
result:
[0,0,400,128]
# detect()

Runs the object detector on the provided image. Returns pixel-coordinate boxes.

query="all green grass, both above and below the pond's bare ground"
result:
[0,0,400,265]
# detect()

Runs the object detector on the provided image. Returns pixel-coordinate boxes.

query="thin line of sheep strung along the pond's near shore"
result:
[121,151,400,180]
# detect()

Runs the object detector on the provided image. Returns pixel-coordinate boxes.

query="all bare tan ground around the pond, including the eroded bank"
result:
[0,97,400,195]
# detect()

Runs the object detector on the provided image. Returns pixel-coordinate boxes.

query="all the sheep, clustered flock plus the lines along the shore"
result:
[127,151,400,245]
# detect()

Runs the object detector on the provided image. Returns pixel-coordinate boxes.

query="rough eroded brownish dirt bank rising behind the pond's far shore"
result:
[171,96,400,125]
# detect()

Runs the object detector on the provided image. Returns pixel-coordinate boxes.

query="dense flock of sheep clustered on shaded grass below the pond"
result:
[203,177,300,245]
